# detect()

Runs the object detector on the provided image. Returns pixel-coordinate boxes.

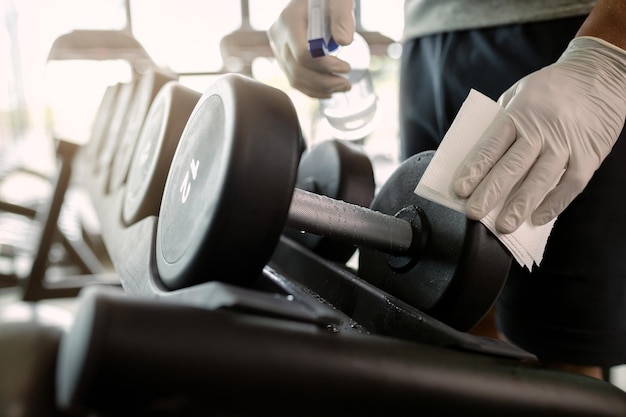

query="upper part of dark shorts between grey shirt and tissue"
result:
[399,18,583,159]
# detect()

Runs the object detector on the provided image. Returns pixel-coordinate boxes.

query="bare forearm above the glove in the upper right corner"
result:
[576,0,626,50]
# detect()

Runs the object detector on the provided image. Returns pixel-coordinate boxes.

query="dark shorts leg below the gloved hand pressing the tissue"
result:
[497,122,626,367]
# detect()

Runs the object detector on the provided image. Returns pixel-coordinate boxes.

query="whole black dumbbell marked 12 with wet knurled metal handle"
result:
[155,74,511,329]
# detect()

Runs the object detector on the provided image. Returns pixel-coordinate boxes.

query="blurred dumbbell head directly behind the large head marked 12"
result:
[122,81,201,225]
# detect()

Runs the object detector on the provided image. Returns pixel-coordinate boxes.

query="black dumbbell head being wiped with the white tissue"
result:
[359,151,511,331]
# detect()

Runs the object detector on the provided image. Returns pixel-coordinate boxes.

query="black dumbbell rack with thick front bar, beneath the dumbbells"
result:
[52,141,626,417]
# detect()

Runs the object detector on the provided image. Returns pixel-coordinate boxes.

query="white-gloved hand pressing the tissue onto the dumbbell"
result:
[454,37,626,233]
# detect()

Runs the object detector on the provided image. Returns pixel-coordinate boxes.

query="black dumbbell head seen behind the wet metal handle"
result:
[285,140,376,263]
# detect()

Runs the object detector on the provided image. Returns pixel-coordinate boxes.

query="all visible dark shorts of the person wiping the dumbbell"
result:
[400,17,626,366]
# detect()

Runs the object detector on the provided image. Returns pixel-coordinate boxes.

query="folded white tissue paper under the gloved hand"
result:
[415,90,554,270]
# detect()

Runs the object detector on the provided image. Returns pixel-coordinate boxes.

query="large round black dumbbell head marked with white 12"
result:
[155,74,300,289]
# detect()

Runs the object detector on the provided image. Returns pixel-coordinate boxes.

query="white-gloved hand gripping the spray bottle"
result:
[267,0,355,98]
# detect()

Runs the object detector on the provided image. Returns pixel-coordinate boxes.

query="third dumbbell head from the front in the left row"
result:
[107,69,175,192]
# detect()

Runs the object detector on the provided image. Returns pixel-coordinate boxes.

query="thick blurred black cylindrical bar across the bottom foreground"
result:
[57,288,626,417]
